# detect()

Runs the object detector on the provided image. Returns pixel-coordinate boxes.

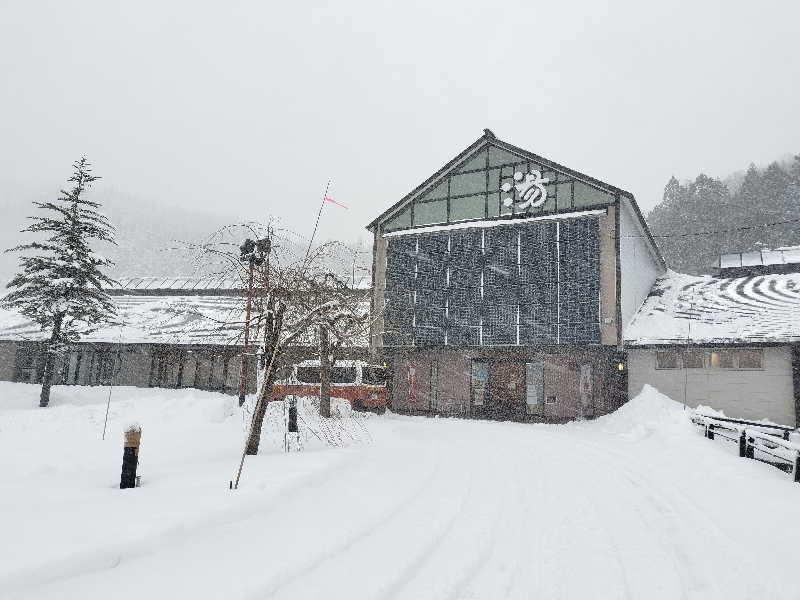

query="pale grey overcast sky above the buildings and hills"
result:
[0,0,800,244]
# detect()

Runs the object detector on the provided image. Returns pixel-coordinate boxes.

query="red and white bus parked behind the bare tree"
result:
[272,360,386,412]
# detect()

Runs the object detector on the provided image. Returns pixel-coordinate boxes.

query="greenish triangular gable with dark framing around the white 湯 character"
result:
[367,129,633,230]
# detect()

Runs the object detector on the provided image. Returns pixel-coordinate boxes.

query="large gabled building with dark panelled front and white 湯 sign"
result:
[368,130,665,421]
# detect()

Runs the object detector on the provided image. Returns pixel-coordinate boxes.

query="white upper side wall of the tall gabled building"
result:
[619,197,665,333]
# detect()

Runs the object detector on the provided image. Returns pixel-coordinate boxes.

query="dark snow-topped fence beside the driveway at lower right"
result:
[692,413,800,483]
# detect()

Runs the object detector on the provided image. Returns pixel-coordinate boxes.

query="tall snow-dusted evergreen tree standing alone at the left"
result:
[2,157,115,407]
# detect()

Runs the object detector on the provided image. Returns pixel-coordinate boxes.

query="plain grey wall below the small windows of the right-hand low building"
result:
[628,346,796,426]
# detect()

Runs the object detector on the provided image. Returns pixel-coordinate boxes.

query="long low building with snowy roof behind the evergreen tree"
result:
[0,277,368,394]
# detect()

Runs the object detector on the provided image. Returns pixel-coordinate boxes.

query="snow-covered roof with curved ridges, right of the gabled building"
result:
[624,271,800,346]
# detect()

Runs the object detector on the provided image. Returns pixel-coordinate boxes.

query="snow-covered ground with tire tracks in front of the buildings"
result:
[0,383,800,599]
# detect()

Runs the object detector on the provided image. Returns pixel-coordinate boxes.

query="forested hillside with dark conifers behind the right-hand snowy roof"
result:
[647,155,800,274]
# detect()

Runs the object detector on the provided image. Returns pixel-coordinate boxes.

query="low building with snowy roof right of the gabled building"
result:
[625,272,800,426]
